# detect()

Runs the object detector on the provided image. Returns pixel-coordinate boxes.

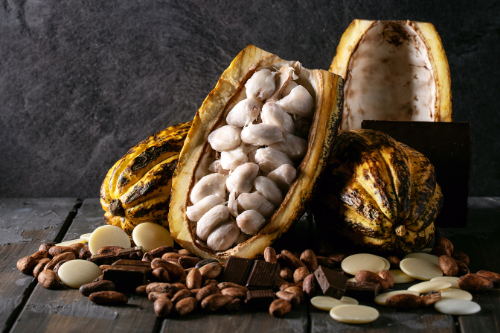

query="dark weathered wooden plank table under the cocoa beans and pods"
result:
[0,197,500,333]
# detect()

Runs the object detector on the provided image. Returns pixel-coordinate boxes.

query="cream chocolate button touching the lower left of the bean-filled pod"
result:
[132,222,174,252]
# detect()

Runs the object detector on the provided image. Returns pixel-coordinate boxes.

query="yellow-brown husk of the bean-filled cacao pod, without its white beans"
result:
[169,45,343,261]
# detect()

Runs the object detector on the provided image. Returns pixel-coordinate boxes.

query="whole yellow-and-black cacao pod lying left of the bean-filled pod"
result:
[101,122,191,235]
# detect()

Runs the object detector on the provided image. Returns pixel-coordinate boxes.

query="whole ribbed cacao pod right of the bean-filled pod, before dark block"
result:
[312,130,443,253]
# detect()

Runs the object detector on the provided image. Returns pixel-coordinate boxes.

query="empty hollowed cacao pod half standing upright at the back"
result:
[330,20,452,130]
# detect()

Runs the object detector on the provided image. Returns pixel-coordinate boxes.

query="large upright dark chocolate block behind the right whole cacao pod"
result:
[361,120,472,227]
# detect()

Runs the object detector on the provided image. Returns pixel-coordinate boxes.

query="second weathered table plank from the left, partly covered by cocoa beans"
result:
[12,199,160,333]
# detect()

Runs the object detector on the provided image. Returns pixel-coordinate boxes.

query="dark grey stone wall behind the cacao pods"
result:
[0,0,500,198]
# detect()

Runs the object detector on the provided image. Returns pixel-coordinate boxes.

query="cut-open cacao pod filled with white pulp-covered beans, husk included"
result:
[169,45,343,261]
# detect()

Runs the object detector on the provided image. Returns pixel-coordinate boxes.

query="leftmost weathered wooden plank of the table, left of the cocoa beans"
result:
[0,198,77,332]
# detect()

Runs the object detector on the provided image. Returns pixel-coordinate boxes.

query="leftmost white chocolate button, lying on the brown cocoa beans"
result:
[57,259,102,288]
